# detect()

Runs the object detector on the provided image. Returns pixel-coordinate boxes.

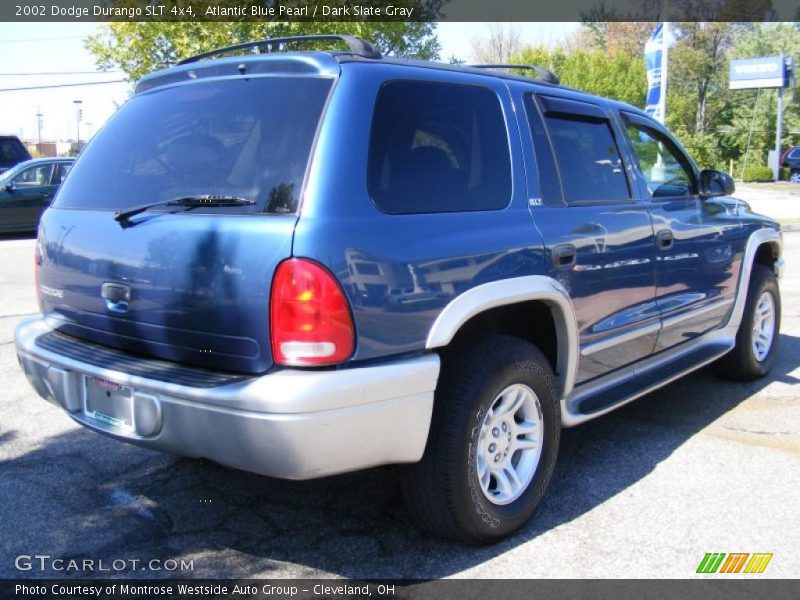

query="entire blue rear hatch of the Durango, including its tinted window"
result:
[38,58,338,373]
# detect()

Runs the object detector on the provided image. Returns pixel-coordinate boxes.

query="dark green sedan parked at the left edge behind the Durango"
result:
[0,158,75,233]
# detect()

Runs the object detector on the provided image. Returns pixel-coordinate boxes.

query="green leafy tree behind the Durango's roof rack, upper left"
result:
[85,0,440,80]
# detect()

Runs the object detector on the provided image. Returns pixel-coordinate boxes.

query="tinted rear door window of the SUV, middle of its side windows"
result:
[546,115,631,202]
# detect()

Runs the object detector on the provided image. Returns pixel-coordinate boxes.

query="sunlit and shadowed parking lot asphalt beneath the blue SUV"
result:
[0,232,800,578]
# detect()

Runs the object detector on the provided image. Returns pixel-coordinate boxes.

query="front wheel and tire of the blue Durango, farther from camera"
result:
[714,265,781,381]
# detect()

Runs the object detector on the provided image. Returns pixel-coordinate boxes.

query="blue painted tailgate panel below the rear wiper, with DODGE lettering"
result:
[39,209,296,373]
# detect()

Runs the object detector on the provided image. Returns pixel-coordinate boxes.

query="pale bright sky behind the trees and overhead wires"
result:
[0,23,578,141]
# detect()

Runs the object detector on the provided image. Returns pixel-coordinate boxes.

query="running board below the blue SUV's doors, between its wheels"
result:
[561,330,735,427]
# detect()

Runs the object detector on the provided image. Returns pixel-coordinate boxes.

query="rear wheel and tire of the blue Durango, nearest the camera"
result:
[403,335,561,544]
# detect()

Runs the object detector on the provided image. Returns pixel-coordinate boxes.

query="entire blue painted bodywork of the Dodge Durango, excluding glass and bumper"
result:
[34,53,775,382]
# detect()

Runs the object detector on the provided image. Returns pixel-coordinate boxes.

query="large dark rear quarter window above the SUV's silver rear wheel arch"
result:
[368,81,511,214]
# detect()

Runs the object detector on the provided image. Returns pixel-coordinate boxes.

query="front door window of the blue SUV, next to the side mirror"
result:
[627,124,692,198]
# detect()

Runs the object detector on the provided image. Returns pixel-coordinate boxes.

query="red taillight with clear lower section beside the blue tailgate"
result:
[269,258,354,366]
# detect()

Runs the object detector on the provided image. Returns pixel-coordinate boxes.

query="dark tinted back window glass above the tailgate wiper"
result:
[56,77,331,214]
